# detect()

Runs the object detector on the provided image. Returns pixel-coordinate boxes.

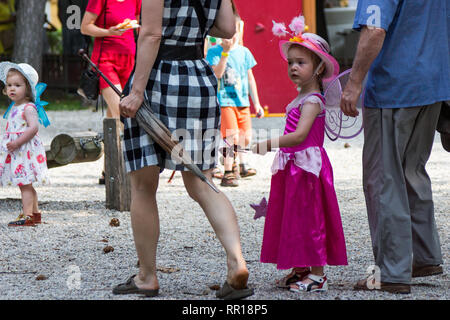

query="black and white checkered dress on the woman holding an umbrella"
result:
[122,0,221,172]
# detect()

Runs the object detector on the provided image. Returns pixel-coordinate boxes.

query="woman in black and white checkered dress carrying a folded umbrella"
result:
[113,0,253,298]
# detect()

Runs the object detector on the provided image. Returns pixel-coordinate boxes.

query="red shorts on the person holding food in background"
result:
[92,52,134,90]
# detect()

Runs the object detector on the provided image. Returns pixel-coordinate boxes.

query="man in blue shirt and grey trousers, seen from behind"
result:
[341,0,450,293]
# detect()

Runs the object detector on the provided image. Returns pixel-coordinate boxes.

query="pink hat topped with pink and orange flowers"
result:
[272,15,339,81]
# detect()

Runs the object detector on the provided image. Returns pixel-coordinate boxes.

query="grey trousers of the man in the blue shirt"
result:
[363,102,442,283]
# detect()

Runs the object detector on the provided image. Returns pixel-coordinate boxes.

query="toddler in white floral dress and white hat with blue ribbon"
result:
[0,62,50,226]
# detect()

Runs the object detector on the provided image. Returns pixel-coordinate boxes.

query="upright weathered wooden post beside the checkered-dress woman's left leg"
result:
[103,118,131,211]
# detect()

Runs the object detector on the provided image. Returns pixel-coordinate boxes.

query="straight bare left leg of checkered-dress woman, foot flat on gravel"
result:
[130,166,159,289]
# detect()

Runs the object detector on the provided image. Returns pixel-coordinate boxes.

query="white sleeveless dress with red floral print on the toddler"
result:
[0,103,49,186]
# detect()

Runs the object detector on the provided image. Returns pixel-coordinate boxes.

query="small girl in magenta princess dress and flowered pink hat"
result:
[252,16,347,292]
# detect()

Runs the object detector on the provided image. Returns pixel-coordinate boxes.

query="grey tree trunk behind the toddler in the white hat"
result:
[13,0,47,75]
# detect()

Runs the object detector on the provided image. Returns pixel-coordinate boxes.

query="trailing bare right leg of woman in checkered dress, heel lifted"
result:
[182,170,249,289]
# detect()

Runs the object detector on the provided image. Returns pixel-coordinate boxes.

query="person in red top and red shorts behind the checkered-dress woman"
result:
[81,0,142,118]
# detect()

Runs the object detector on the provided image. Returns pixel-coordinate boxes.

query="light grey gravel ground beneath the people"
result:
[0,110,450,300]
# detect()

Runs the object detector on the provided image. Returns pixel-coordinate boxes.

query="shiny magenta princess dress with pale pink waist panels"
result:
[261,95,347,269]
